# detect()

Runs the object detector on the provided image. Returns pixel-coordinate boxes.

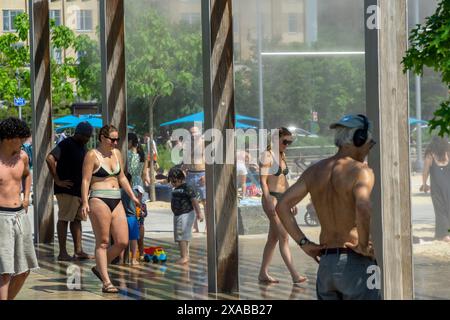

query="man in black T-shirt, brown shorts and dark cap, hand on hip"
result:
[46,121,94,261]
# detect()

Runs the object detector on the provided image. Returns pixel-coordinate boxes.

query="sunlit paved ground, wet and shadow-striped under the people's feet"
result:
[17,176,450,300]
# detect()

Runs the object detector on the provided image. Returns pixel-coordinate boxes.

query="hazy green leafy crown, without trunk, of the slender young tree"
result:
[126,7,202,132]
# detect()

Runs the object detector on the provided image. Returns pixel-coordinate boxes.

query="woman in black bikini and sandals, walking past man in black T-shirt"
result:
[81,125,140,293]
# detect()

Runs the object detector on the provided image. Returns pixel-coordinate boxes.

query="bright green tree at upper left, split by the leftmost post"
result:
[0,13,99,122]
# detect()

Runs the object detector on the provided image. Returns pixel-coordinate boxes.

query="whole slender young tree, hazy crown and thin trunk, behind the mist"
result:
[126,6,201,199]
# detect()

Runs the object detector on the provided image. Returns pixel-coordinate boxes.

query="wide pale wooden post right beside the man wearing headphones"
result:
[364,0,413,299]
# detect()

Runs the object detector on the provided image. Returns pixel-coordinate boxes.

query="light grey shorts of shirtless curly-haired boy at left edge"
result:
[0,209,39,275]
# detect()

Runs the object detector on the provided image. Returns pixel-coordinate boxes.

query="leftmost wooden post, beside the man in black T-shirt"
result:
[29,0,54,243]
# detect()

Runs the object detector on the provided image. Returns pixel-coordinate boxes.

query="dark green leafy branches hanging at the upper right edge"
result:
[402,0,450,136]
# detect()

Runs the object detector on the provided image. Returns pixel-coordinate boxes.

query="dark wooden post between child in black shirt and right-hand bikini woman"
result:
[202,0,239,293]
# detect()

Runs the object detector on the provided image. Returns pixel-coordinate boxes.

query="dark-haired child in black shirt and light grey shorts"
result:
[168,168,203,264]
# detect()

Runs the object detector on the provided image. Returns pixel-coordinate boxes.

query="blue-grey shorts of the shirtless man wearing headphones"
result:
[316,250,381,300]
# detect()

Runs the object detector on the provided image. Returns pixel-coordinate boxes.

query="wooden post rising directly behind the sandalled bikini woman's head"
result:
[100,0,127,155]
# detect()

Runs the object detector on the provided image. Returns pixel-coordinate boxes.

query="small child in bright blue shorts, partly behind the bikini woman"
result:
[121,174,139,266]
